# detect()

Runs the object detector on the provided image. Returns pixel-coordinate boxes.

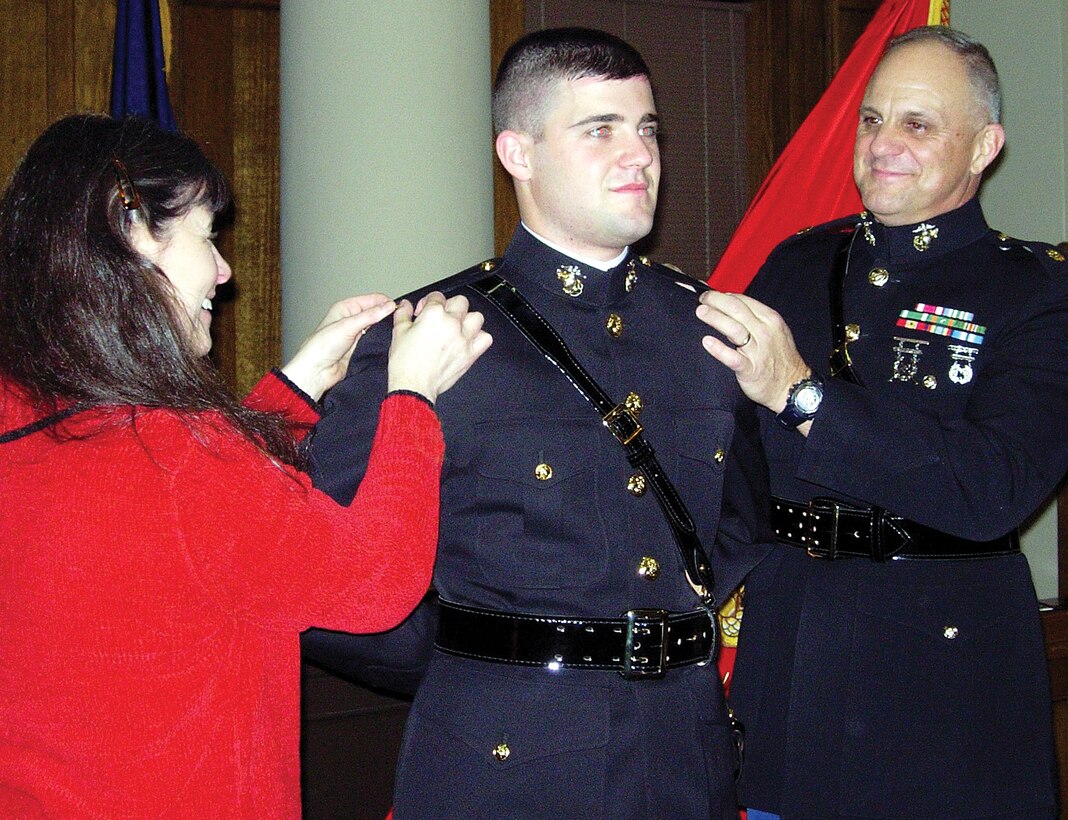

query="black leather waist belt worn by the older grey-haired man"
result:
[771,498,1020,562]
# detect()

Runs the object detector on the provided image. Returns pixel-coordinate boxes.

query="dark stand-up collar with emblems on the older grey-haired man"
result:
[857,196,990,265]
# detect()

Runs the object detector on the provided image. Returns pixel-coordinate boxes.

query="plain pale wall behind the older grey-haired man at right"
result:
[949,0,1068,598]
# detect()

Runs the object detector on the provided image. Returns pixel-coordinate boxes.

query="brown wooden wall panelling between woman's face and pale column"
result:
[170,0,282,394]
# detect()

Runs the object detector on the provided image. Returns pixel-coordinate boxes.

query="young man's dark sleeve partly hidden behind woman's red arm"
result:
[300,325,437,694]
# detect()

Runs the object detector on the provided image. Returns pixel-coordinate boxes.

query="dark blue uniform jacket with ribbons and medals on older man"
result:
[732,200,1068,820]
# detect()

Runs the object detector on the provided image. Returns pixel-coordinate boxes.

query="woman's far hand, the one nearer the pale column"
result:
[282,294,396,401]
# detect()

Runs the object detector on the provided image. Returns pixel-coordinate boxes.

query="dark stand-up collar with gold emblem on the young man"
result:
[503,225,631,305]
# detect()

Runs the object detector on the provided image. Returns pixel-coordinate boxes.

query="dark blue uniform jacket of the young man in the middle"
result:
[305,227,768,820]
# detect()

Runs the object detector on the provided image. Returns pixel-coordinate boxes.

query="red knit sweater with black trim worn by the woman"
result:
[0,376,444,818]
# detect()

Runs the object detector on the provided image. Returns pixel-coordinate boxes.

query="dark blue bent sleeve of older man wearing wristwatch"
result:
[797,283,1068,540]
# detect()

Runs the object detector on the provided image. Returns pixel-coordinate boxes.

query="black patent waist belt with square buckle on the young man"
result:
[435,600,716,679]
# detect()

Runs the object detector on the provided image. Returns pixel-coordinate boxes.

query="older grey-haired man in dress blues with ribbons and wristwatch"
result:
[698,27,1068,820]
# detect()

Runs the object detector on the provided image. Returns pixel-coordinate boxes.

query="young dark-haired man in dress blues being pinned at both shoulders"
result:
[305,29,770,820]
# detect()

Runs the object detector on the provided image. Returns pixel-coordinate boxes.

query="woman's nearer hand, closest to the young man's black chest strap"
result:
[389,291,493,403]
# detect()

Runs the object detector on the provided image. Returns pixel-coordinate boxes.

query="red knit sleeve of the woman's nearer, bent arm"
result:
[163,395,444,632]
